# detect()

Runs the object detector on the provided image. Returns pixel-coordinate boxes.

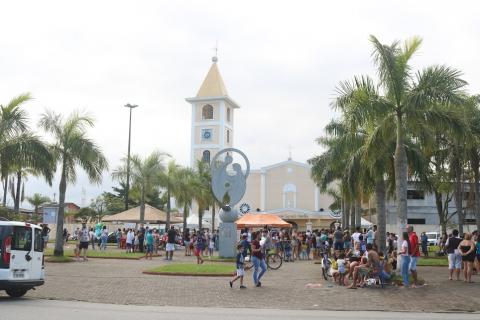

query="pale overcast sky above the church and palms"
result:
[0,0,480,207]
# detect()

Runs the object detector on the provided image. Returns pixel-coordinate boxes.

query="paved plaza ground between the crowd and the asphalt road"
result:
[0,252,480,312]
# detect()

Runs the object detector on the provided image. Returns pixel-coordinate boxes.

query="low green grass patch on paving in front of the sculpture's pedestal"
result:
[146,263,235,275]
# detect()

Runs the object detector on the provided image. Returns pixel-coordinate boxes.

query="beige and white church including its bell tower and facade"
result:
[186,57,338,230]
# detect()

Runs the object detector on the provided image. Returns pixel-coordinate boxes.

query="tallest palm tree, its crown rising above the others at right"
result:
[345,36,466,240]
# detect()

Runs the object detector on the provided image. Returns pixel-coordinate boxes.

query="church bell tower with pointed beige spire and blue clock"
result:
[185,56,240,168]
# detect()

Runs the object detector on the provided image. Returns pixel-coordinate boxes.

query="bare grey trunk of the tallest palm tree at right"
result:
[394,113,408,239]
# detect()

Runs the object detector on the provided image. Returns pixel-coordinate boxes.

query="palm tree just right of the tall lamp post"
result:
[112,151,167,223]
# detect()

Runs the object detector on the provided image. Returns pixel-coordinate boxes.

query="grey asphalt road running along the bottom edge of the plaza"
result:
[0,298,480,320]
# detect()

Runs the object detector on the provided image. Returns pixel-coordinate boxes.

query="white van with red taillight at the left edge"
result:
[0,221,45,297]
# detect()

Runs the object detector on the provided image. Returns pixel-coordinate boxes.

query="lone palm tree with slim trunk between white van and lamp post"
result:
[39,111,108,256]
